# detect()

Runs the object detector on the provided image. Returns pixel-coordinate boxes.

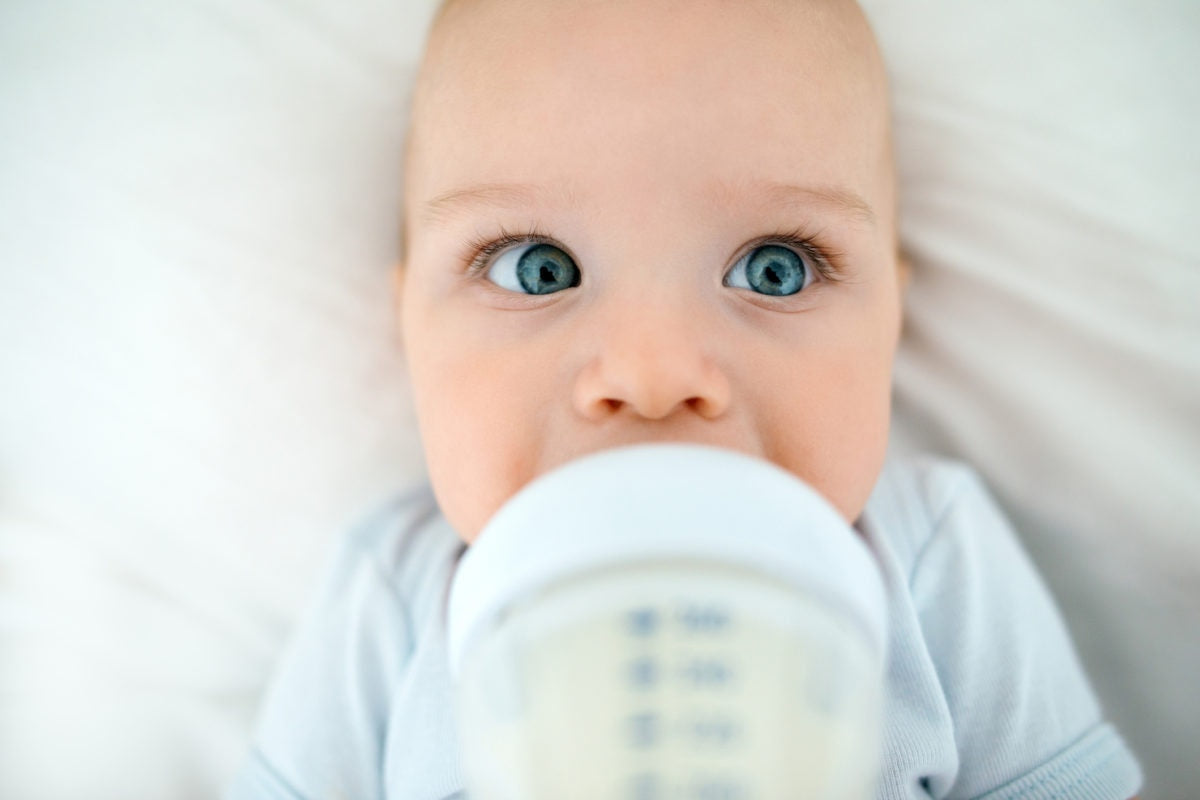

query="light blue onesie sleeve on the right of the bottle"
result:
[910,468,1141,800]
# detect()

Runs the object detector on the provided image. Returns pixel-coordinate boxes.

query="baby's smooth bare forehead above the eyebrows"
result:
[406,0,890,235]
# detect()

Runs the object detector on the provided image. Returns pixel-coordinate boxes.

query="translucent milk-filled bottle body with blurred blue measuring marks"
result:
[460,563,880,800]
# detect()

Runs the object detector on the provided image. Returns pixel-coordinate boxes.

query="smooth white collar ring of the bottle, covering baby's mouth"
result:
[449,444,887,676]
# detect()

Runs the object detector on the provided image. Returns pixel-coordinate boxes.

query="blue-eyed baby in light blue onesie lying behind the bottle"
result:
[232,0,1140,800]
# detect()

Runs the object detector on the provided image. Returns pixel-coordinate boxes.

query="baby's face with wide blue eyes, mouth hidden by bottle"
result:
[401,0,900,541]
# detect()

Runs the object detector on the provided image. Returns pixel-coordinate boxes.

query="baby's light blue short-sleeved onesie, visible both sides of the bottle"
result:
[228,458,1141,800]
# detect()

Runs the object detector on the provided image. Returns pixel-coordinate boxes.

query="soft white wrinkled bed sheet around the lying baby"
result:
[0,0,1200,800]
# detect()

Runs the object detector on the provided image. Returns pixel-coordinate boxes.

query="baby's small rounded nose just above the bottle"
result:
[574,299,731,421]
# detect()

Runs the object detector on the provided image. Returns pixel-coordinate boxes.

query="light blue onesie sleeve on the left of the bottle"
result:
[226,494,432,800]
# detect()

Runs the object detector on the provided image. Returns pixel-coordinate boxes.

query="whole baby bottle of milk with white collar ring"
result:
[449,444,887,800]
